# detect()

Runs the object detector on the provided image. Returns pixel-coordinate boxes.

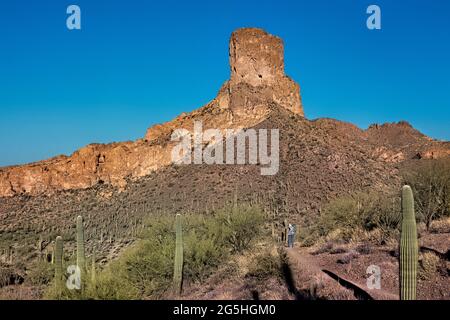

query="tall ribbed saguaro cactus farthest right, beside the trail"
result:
[400,186,418,300]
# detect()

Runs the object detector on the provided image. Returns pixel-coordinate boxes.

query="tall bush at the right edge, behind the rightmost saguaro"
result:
[403,159,450,230]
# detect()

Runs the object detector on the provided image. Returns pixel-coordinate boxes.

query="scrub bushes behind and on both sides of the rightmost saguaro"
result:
[300,159,450,245]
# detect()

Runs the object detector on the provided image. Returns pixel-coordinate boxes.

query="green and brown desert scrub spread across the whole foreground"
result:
[5,162,450,300]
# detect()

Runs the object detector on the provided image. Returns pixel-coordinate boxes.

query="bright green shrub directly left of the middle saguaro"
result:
[82,216,179,300]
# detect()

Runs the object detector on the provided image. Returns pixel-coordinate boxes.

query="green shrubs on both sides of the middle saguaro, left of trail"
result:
[45,206,263,299]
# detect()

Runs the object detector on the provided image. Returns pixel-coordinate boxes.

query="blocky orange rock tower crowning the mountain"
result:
[218,28,304,116]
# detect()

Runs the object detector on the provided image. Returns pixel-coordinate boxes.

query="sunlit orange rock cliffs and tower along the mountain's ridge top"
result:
[0,28,450,197]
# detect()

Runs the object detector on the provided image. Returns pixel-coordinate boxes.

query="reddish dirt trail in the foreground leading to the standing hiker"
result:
[287,248,398,300]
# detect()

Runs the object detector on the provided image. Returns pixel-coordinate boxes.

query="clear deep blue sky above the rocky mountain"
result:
[0,0,450,166]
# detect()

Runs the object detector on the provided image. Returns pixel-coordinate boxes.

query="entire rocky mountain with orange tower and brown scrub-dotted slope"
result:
[0,29,450,261]
